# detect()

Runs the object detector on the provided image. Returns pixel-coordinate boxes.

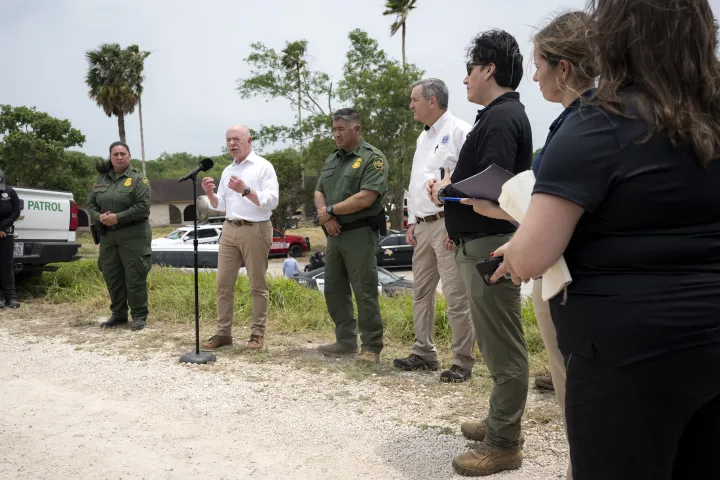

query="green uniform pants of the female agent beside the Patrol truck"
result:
[98,223,152,320]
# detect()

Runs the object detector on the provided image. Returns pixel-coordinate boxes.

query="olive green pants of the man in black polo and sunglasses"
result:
[455,235,530,448]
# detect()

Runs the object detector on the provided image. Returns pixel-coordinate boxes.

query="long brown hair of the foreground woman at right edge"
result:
[587,0,720,166]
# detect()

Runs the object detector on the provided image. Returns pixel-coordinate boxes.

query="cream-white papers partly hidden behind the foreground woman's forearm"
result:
[499,170,572,302]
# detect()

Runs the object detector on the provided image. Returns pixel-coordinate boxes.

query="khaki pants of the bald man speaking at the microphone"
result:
[216,221,272,337]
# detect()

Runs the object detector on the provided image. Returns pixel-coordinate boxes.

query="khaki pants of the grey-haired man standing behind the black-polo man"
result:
[412,218,475,370]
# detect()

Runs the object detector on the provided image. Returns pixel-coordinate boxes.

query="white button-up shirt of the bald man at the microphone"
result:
[217,152,280,222]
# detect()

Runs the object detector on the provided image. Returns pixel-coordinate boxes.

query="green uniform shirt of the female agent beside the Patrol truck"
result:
[88,166,150,225]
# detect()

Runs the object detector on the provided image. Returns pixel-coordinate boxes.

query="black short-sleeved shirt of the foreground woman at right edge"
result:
[534,97,720,365]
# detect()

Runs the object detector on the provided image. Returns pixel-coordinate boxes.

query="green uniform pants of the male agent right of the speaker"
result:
[325,227,383,353]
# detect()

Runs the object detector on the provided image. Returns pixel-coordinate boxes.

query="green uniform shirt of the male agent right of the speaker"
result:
[315,138,388,225]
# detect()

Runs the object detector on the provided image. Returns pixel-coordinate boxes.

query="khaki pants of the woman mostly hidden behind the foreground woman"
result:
[532,278,572,480]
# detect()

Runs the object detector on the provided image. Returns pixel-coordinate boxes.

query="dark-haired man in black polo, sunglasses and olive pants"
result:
[429,30,532,476]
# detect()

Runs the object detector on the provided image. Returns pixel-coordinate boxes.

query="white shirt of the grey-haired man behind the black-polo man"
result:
[407,110,472,225]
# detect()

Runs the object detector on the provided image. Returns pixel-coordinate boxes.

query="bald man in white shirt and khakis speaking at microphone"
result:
[202,125,279,350]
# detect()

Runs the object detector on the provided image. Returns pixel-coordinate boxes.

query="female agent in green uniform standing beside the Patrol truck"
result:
[88,142,152,330]
